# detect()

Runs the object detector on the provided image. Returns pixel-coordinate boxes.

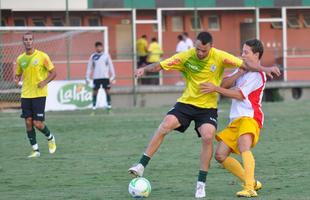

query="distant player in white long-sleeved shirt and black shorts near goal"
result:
[86,42,115,110]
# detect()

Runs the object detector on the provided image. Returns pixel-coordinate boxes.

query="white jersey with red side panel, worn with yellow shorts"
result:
[229,69,266,127]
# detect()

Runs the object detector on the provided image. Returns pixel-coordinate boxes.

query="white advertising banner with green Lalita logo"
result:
[45,80,107,111]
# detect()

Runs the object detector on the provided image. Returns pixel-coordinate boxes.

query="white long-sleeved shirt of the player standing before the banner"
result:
[86,52,115,80]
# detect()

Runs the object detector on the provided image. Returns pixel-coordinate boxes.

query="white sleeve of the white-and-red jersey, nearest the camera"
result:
[238,72,264,98]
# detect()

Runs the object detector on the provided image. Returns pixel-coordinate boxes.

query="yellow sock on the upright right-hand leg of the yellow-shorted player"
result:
[241,151,255,190]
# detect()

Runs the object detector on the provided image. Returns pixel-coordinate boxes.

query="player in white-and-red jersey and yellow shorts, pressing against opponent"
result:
[201,39,266,197]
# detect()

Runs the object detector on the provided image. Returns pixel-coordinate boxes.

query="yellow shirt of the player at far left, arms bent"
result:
[16,50,54,98]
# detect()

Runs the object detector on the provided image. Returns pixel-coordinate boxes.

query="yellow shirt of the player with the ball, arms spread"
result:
[160,48,243,108]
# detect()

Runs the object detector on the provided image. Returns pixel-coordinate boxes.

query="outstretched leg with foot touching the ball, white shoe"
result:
[128,114,180,176]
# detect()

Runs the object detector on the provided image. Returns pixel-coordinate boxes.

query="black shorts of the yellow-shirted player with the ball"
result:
[167,102,217,137]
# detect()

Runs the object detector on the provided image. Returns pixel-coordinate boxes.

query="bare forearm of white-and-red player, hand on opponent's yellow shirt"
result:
[200,82,244,101]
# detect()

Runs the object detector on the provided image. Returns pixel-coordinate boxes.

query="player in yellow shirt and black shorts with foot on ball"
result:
[128,32,280,198]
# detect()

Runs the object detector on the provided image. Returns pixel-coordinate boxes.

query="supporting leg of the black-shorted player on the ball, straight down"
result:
[195,123,216,198]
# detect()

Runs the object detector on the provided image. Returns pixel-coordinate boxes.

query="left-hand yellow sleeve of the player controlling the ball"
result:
[160,51,187,71]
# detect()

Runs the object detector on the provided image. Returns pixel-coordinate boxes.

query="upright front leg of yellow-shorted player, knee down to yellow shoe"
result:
[237,133,257,197]
